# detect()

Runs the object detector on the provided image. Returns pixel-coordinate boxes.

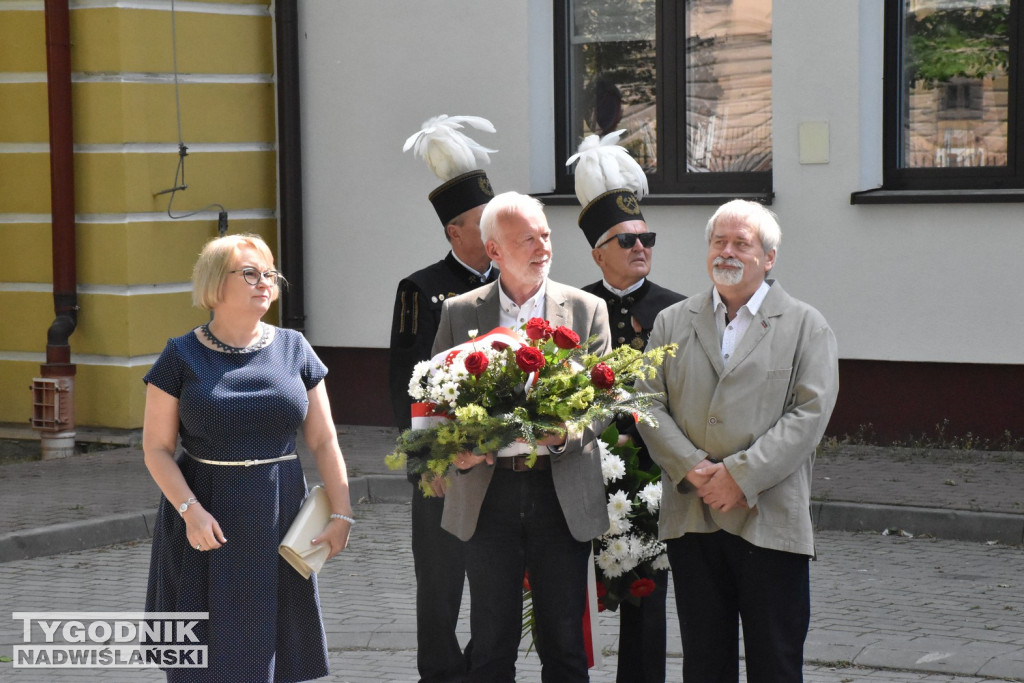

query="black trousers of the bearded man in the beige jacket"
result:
[667,531,811,683]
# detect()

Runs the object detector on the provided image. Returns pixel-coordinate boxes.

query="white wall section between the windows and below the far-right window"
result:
[772,0,1024,364]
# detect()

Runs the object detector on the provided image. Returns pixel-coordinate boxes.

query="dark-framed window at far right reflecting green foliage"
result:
[864,0,1024,197]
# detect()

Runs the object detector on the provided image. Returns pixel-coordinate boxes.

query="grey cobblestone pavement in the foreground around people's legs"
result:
[0,503,1024,683]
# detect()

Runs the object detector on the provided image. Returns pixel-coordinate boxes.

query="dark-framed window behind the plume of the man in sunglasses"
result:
[555,0,772,203]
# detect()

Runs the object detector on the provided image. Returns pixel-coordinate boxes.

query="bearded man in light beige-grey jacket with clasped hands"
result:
[638,200,839,683]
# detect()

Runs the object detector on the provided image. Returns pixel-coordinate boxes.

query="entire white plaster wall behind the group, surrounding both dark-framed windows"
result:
[300,0,1024,364]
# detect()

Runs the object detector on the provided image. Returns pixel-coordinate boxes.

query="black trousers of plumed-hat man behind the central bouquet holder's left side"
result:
[413,485,470,683]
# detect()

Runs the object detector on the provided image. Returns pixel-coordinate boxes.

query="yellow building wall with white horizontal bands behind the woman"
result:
[0,0,278,428]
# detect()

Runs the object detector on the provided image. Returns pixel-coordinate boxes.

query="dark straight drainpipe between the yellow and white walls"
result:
[274,0,306,332]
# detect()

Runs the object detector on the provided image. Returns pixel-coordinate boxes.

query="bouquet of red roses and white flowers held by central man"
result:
[385,317,677,496]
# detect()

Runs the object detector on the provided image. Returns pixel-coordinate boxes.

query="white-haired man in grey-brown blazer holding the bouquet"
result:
[432,193,610,683]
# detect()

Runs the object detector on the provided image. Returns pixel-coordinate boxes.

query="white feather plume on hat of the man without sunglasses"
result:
[401,114,498,181]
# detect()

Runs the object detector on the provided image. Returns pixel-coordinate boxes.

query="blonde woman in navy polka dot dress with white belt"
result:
[142,234,352,683]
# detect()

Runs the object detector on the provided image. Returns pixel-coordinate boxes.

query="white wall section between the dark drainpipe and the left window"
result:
[299,0,554,347]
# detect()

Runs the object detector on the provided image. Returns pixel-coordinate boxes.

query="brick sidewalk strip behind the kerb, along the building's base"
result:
[0,425,1024,536]
